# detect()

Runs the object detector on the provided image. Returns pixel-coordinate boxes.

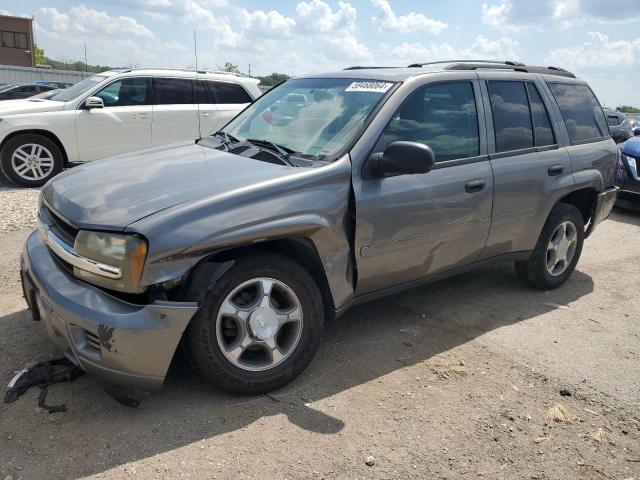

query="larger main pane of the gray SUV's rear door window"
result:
[489,81,533,152]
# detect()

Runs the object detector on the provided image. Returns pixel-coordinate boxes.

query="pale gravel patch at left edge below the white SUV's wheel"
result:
[0,174,40,232]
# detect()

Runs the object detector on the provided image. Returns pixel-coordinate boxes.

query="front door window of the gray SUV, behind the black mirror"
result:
[375,82,480,162]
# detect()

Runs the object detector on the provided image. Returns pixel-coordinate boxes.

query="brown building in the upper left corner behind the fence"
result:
[0,15,36,67]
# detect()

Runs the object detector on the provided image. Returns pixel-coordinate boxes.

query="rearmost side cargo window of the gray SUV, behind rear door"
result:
[549,83,609,142]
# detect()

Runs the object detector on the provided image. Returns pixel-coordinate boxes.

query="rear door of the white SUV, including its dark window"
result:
[152,77,200,146]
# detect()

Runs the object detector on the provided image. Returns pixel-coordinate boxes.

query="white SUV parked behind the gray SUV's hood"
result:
[0,69,261,187]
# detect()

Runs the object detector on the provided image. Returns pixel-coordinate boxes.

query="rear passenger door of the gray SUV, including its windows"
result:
[479,72,573,259]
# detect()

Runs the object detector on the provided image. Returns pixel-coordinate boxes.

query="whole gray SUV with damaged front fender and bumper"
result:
[21,62,618,393]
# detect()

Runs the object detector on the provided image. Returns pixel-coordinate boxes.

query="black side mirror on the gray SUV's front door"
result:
[363,141,436,179]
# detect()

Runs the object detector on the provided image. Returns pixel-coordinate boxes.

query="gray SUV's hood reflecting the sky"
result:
[42,142,299,230]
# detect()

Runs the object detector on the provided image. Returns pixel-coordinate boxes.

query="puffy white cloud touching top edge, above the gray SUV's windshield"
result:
[296,0,357,33]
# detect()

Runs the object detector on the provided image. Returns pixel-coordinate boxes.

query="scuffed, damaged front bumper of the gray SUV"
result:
[21,232,197,391]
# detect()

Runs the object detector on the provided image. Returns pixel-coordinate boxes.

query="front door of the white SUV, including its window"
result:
[76,77,152,162]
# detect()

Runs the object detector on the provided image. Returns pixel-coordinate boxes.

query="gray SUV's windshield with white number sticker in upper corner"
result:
[224,78,393,157]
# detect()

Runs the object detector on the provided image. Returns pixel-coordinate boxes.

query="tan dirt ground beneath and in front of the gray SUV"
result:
[0,207,640,480]
